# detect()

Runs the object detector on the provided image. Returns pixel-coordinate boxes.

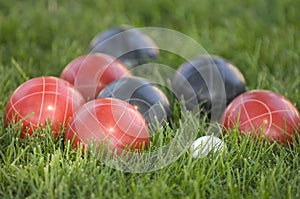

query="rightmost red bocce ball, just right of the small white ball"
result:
[221,90,300,144]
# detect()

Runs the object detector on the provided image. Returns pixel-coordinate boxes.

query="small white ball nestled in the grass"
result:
[190,135,225,159]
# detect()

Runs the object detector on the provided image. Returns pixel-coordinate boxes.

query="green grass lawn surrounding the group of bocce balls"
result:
[0,0,300,198]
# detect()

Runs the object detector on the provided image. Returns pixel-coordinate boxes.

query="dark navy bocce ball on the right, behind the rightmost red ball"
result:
[172,56,246,114]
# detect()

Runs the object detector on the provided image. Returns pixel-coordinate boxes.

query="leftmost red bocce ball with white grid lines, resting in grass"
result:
[5,76,84,138]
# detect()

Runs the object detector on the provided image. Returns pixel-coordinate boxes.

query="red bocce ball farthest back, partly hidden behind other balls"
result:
[60,53,130,101]
